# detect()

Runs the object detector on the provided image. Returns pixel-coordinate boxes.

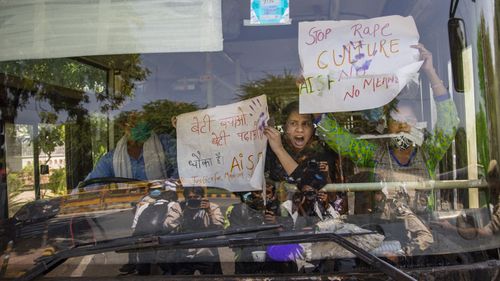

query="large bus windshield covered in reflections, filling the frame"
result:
[0,0,500,279]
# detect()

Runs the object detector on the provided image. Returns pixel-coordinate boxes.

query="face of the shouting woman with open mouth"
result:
[285,111,313,151]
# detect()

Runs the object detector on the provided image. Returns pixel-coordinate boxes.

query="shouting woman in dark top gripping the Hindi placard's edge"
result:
[264,101,347,212]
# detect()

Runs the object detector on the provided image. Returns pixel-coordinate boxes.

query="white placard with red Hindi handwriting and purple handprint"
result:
[177,95,269,191]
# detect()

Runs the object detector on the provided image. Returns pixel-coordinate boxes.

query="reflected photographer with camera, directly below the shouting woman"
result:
[281,165,340,230]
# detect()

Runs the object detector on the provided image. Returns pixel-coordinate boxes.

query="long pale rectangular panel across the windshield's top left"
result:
[0,0,222,61]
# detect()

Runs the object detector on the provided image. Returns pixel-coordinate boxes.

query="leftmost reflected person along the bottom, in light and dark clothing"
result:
[127,181,182,275]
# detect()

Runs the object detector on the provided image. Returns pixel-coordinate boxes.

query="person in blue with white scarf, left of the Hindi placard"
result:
[81,111,177,189]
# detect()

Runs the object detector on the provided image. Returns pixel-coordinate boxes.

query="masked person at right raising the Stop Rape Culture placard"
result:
[316,44,459,213]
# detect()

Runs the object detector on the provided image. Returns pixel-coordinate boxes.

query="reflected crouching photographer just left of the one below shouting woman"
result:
[224,180,280,274]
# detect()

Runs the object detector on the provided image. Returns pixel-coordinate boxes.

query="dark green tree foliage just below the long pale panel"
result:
[0,55,149,116]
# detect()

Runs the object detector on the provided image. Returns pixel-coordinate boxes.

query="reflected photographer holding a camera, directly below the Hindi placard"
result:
[172,186,224,275]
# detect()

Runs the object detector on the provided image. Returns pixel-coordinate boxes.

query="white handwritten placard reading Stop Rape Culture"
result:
[299,16,422,113]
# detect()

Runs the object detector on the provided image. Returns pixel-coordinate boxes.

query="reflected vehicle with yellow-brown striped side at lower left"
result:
[0,181,157,254]
